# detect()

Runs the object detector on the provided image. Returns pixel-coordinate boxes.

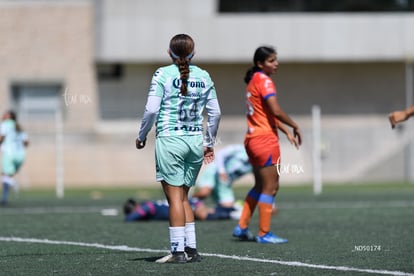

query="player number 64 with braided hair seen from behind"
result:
[136,34,221,263]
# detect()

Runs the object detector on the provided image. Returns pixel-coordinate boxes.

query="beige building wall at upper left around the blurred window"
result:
[0,1,98,132]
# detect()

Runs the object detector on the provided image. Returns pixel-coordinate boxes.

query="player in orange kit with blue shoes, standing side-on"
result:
[233,46,302,243]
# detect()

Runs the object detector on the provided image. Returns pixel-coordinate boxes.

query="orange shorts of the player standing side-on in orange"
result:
[244,133,280,167]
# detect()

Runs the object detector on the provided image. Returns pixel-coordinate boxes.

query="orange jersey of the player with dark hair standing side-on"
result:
[246,72,277,138]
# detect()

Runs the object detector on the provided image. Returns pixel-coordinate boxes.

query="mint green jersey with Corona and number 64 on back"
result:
[148,64,217,137]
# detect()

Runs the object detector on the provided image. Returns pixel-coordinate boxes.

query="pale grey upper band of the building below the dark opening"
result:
[95,0,414,63]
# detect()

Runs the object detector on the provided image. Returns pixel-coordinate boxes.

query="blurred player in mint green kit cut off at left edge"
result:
[0,111,29,205]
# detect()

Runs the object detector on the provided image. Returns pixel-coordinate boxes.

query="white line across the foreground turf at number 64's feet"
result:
[0,237,414,276]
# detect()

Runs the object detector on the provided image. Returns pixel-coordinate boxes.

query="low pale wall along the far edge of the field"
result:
[18,115,414,188]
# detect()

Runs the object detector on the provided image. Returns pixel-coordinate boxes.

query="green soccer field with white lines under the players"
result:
[0,184,414,276]
